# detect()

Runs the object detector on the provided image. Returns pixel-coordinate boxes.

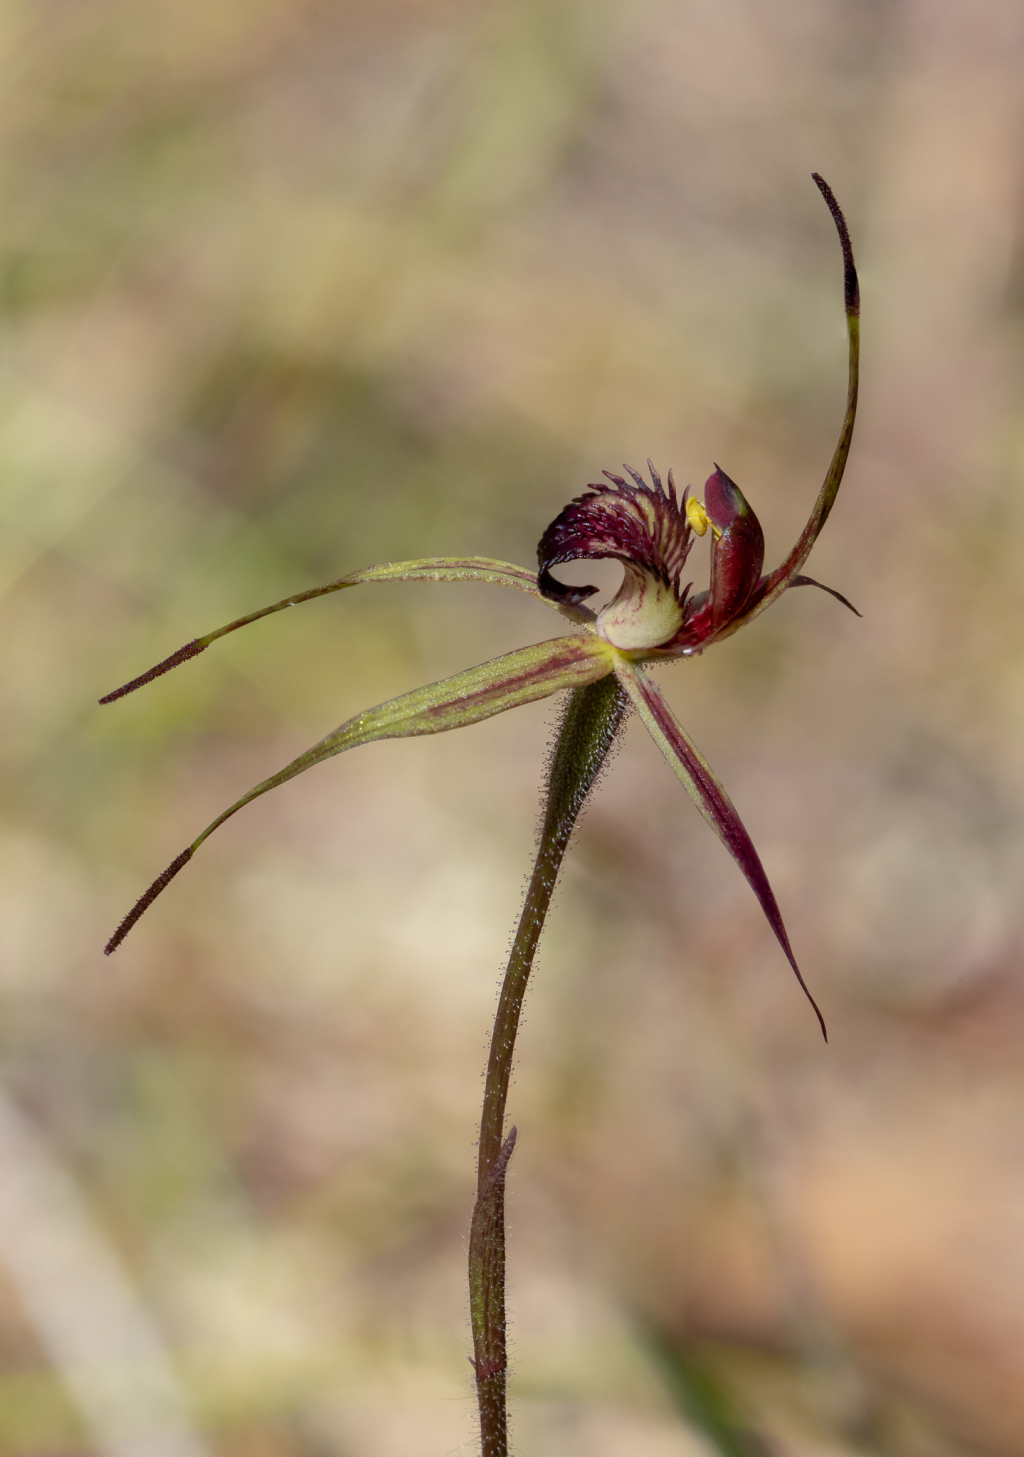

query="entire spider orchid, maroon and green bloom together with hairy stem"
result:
[101,173,859,1457]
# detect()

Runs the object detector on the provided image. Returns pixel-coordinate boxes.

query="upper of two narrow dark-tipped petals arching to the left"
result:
[99,557,594,704]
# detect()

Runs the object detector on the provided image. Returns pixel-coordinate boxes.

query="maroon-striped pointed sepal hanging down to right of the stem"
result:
[615,657,829,1042]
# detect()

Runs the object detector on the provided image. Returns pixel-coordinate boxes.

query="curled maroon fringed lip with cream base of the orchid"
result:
[537,460,690,650]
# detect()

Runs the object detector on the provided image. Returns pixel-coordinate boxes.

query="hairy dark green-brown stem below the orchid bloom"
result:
[469,675,628,1457]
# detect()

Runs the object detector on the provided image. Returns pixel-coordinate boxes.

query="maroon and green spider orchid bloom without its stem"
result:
[101,173,859,1033]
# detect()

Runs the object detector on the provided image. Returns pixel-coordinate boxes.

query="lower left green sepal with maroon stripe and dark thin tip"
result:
[106,632,615,956]
